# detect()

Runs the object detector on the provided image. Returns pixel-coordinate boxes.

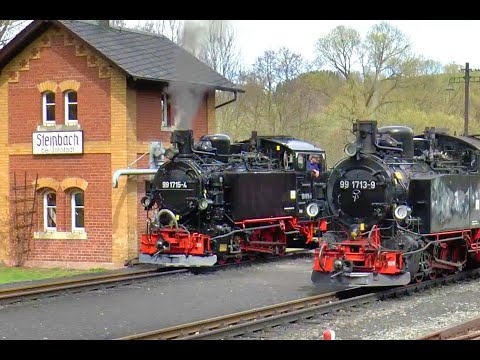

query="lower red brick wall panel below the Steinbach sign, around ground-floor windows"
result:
[10,154,112,262]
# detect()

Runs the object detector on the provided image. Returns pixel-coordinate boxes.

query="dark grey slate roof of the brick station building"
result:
[0,20,244,92]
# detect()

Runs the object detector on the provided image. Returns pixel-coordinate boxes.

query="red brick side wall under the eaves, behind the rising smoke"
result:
[137,88,207,142]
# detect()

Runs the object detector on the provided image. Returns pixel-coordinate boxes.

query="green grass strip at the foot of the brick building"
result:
[0,265,106,284]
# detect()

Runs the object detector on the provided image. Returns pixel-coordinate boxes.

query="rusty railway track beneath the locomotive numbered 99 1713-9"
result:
[117,269,480,340]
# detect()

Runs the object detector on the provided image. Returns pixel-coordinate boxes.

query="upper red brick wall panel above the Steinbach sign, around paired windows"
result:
[8,30,110,144]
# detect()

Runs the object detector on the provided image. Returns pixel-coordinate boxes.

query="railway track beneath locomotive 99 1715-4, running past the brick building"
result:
[0,251,309,305]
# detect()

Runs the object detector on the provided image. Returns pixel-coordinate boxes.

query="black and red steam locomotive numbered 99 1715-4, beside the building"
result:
[139,130,325,266]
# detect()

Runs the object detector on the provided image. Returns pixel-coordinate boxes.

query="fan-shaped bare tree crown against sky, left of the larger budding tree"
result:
[316,25,361,80]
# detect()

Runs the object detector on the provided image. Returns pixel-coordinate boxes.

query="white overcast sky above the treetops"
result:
[231,20,480,68]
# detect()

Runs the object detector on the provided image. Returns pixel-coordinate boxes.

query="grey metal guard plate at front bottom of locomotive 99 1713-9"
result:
[312,271,411,286]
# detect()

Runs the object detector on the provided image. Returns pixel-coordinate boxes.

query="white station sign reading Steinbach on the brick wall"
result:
[32,130,83,155]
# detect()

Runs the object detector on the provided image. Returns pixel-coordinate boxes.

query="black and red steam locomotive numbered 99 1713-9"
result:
[312,121,480,286]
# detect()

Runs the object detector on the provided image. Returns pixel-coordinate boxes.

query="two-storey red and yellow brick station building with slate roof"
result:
[0,20,241,268]
